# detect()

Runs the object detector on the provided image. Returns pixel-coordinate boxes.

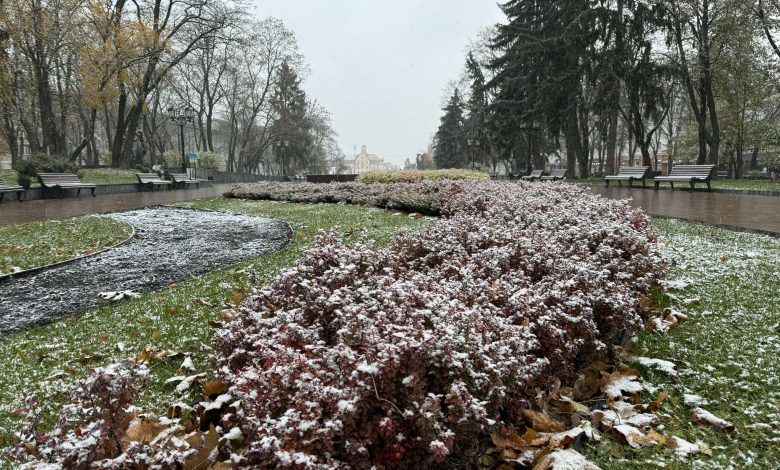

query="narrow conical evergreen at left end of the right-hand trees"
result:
[433,89,468,168]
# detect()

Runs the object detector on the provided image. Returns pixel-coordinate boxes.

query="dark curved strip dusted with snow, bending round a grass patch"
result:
[0,207,292,336]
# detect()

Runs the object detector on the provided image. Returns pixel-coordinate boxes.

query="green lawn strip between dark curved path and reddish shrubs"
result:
[0,199,432,460]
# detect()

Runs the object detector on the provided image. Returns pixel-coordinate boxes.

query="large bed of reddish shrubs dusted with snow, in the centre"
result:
[211,183,663,468]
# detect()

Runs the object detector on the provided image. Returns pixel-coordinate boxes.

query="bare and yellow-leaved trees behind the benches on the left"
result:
[0,0,341,175]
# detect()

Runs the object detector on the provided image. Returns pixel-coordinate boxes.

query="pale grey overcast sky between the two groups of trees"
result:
[254,0,503,165]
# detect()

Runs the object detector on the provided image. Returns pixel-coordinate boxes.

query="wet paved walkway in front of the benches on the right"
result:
[592,187,780,236]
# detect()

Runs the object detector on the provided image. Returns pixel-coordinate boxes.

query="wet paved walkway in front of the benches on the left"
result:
[0,184,233,225]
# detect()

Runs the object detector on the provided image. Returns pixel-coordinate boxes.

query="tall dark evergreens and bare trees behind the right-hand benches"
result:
[434,0,780,177]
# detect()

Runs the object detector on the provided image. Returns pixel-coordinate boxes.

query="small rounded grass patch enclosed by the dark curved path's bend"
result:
[0,216,133,274]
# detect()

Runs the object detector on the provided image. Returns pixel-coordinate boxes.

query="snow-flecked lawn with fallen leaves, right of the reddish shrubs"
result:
[587,219,780,469]
